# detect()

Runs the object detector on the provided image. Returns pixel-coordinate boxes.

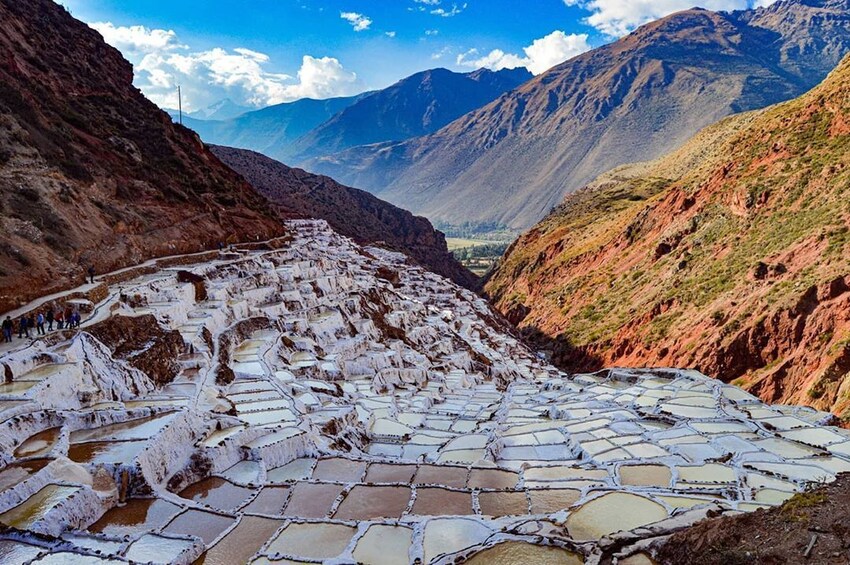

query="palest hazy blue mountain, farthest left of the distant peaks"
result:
[176,95,363,161]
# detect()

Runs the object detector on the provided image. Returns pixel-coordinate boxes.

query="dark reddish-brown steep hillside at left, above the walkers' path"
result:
[0,0,282,309]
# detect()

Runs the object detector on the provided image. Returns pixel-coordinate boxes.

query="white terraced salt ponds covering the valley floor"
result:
[0,221,850,565]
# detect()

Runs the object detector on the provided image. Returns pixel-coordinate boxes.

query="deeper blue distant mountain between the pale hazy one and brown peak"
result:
[291,68,532,161]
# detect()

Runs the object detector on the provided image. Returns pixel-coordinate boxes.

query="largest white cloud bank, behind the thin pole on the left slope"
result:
[93,23,363,111]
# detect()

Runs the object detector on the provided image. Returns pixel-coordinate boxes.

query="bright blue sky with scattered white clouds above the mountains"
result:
[59,0,773,112]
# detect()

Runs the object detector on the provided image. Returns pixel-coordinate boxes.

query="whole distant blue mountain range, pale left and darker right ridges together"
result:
[184,69,531,166]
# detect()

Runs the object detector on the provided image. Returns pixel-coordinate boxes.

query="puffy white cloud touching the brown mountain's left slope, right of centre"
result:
[457,31,590,75]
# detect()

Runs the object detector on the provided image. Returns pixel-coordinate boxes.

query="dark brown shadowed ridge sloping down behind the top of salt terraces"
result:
[211,146,477,288]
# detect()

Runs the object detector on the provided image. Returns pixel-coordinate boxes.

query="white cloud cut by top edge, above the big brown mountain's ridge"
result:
[564,0,776,37]
